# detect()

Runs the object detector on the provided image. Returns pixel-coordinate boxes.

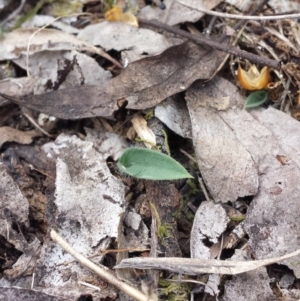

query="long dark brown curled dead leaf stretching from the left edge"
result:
[0,43,224,119]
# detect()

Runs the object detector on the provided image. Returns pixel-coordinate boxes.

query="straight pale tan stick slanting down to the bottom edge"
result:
[50,229,148,301]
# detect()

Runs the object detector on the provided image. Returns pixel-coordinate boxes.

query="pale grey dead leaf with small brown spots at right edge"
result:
[244,108,300,278]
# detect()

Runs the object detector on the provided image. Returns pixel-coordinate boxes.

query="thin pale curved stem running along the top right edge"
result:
[177,0,300,21]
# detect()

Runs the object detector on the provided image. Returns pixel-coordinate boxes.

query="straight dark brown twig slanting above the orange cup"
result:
[139,18,280,69]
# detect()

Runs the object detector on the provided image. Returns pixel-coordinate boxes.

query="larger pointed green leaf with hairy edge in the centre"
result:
[117,147,193,180]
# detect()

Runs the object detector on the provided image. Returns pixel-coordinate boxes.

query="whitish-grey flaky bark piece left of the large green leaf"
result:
[43,134,125,246]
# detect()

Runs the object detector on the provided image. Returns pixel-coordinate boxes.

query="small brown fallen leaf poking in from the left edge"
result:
[0,126,40,147]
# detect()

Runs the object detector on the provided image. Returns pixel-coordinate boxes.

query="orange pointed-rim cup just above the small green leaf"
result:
[238,65,270,91]
